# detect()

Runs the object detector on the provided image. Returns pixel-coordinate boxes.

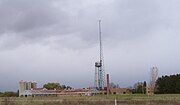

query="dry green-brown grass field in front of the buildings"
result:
[0,94,180,105]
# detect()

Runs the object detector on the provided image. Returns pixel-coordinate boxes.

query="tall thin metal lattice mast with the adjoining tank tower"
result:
[94,20,105,90]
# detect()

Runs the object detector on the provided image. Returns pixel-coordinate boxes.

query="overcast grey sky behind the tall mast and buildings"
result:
[0,0,180,91]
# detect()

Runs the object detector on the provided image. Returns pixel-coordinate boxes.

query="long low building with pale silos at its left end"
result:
[19,81,95,97]
